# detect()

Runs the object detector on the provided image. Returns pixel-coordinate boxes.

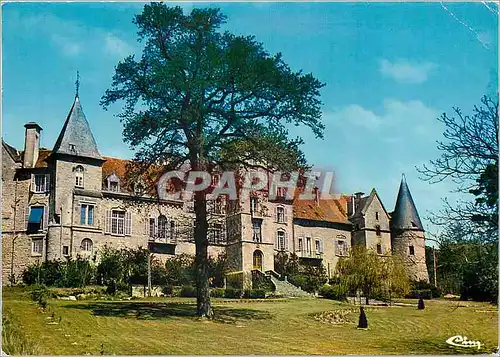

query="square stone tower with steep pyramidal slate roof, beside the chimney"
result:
[47,84,105,260]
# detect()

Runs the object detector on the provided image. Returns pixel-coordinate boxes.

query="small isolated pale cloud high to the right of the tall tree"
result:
[379,59,437,84]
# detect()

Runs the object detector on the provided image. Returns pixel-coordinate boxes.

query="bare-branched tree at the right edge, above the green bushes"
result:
[418,96,498,242]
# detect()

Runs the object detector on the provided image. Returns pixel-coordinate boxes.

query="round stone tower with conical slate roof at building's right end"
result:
[390,174,429,282]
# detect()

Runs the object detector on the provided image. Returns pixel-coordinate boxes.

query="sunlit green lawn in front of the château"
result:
[3,288,498,355]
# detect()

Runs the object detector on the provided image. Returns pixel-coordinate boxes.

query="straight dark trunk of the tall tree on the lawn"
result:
[194,191,214,319]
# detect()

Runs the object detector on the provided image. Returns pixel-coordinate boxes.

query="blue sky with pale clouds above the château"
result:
[2,2,498,239]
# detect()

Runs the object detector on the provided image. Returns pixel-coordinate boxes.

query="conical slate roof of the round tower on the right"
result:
[391,175,424,231]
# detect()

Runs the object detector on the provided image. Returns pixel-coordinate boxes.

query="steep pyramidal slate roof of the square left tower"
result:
[52,96,102,159]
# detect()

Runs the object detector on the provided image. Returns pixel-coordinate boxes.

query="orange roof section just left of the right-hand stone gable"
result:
[293,189,351,224]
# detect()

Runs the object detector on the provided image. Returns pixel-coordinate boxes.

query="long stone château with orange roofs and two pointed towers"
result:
[2,95,428,286]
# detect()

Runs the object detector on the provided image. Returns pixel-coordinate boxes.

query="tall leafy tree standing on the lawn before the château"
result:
[102,3,323,318]
